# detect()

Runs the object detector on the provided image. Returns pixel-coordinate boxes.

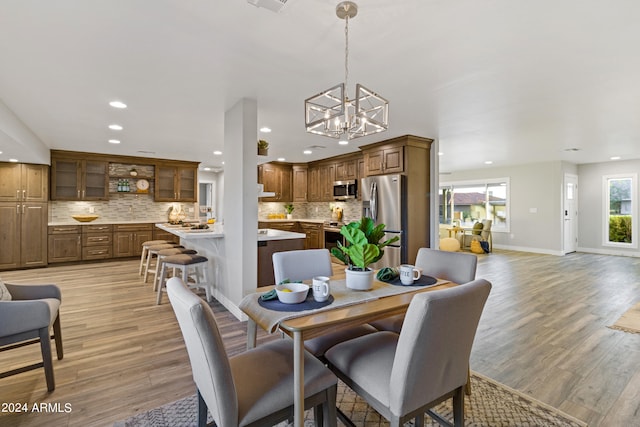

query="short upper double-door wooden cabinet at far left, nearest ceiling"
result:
[0,162,49,202]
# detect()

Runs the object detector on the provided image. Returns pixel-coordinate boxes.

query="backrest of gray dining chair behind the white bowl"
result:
[272,249,332,284]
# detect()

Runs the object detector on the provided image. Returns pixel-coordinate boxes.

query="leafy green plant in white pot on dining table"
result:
[331,217,400,290]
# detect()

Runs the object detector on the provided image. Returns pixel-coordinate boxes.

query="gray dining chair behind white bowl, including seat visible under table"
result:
[272,249,377,358]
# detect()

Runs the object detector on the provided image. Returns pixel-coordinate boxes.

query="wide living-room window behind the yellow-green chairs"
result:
[439,178,509,231]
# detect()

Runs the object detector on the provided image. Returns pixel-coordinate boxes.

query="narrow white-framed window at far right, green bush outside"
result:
[602,174,638,248]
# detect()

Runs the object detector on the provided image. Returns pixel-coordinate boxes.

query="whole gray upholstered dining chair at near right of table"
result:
[325,279,491,427]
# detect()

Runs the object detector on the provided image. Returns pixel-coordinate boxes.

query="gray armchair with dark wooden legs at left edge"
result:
[0,283,63,391]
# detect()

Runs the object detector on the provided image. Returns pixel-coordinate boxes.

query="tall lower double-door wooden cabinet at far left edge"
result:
[0,202,48,270]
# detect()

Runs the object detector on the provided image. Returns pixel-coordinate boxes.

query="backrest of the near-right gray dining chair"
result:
[389,279,491,414]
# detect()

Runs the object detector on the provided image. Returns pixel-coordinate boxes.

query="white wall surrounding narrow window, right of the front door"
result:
[578,160,640,256]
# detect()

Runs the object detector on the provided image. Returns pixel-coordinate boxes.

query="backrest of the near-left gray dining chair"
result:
[167,277,238,426]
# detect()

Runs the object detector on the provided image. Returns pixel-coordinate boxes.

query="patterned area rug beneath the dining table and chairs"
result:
[114,372,586,427]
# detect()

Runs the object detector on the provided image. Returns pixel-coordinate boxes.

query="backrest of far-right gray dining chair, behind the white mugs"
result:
[415,248,478,284]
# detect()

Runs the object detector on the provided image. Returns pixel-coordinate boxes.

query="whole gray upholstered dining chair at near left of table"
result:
[167,277,337,427]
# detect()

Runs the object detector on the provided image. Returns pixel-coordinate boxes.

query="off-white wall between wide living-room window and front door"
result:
[440,161,568,255]
